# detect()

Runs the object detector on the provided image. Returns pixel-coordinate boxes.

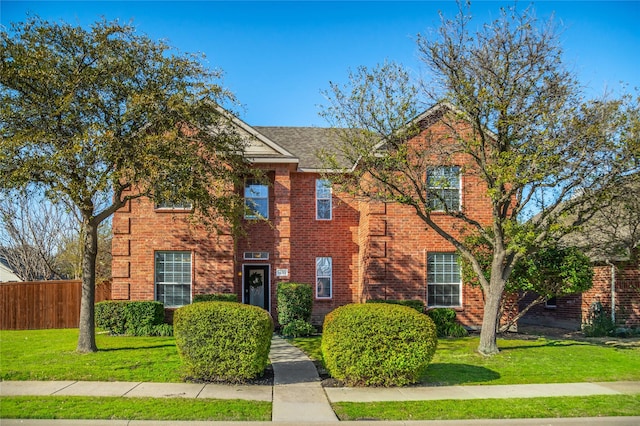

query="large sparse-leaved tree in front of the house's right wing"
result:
[322,6,640,355]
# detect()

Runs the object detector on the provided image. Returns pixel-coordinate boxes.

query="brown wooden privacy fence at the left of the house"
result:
[0,281,111,330]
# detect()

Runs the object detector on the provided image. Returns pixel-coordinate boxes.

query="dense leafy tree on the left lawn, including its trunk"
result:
[0,17,246,352]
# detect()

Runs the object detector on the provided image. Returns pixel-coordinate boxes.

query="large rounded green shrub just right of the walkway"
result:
[322,303,438,386]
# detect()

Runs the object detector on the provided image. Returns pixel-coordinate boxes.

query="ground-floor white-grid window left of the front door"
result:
[155,251,191,307]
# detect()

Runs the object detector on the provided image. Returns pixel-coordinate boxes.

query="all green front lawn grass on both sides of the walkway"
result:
[0,329,640,420]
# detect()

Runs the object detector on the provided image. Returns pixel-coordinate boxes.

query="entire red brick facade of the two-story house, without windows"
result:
[112,111,491,326]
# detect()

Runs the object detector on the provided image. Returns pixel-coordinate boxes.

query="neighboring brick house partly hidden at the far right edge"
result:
[520,175,640,330]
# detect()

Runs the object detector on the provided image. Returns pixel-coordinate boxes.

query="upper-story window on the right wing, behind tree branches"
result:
[427,166,460,211]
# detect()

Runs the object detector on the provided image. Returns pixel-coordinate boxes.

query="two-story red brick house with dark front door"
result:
[112,105,491,327]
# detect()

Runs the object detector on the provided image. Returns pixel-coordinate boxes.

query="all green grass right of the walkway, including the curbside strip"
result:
[292,337,640,420]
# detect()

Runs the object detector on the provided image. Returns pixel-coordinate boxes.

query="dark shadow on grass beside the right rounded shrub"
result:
[420,363,500,386]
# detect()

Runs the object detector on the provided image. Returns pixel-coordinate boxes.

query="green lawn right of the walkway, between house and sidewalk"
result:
[292,337,640,386]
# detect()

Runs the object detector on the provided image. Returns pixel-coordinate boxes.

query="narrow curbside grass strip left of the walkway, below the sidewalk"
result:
[0,396,271,421]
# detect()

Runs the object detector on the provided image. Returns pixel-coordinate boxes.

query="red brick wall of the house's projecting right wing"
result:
[360,116,491,327]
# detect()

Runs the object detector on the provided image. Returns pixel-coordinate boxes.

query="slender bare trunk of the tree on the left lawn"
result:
[76,218,98,352]
